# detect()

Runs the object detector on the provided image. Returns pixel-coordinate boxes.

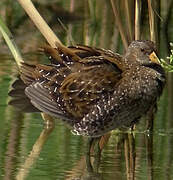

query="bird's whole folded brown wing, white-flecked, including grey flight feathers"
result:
[19,46,122,124]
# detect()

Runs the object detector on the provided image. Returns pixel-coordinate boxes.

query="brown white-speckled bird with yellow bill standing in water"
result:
[8,41,165,137]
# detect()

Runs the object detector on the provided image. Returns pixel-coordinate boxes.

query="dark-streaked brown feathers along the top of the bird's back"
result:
[43,44,123,68]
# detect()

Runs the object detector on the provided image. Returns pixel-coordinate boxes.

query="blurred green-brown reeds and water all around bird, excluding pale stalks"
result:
[0,0,173,180]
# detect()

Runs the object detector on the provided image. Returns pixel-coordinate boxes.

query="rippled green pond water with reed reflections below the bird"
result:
[0,59,173,180]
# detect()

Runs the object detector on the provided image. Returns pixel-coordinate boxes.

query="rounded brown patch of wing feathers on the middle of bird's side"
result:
[59,58,121,119]
